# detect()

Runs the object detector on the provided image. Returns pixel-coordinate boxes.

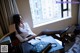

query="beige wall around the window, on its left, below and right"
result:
[16,0,78,34]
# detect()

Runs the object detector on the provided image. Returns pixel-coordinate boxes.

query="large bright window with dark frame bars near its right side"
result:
[29,0,71,27]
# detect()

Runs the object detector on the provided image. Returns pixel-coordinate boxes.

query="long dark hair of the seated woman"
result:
[13,14,22,34]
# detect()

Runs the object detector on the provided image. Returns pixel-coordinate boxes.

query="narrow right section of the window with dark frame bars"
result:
[61,0,71,17]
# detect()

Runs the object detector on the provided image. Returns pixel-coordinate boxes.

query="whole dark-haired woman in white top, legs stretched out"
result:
[13,14,68,42]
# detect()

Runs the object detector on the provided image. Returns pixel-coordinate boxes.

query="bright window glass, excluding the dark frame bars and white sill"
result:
[29,0,71,25]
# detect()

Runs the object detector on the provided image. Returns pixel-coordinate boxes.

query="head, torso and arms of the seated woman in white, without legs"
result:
[13,14,36,42]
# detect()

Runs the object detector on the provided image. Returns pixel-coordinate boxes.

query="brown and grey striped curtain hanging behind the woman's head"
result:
[0,0,19,34]
